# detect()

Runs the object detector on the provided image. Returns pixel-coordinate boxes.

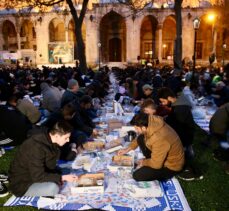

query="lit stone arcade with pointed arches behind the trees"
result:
[0,0,229,65]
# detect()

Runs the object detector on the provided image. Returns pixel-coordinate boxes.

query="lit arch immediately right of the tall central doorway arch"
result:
[140,15,158,61]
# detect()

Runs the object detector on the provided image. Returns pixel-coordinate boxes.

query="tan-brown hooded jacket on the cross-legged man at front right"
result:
[129,115,184,171]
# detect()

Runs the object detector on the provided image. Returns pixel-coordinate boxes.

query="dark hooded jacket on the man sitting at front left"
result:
[9,129,61,196]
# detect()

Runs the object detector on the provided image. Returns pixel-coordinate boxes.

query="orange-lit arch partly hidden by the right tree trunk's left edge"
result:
[162,15,176,60]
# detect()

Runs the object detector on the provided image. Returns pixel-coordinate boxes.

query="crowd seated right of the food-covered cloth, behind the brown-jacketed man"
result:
[112,62,229,181]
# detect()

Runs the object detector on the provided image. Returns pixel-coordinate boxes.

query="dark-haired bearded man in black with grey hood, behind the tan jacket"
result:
[158,87,203,181]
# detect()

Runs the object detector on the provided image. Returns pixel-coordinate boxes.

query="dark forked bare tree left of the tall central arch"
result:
[0,0,89,73]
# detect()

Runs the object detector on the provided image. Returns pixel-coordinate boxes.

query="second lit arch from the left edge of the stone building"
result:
[20,20,36,49]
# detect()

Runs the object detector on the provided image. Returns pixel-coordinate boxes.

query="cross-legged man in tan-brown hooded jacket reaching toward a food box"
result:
[118,113,184,181]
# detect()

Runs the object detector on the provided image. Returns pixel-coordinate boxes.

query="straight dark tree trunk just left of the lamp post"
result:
[173,0,183,72]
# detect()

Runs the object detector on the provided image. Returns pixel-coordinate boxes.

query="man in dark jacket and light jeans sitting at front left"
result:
[9,122,77,196]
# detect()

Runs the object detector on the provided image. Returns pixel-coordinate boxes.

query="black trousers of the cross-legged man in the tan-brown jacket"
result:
[133,166,179,181]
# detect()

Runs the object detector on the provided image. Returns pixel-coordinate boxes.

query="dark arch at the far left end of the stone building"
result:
[2,20,17,50]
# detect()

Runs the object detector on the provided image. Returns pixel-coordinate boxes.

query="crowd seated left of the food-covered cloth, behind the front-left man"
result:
[0,66,109,157]
